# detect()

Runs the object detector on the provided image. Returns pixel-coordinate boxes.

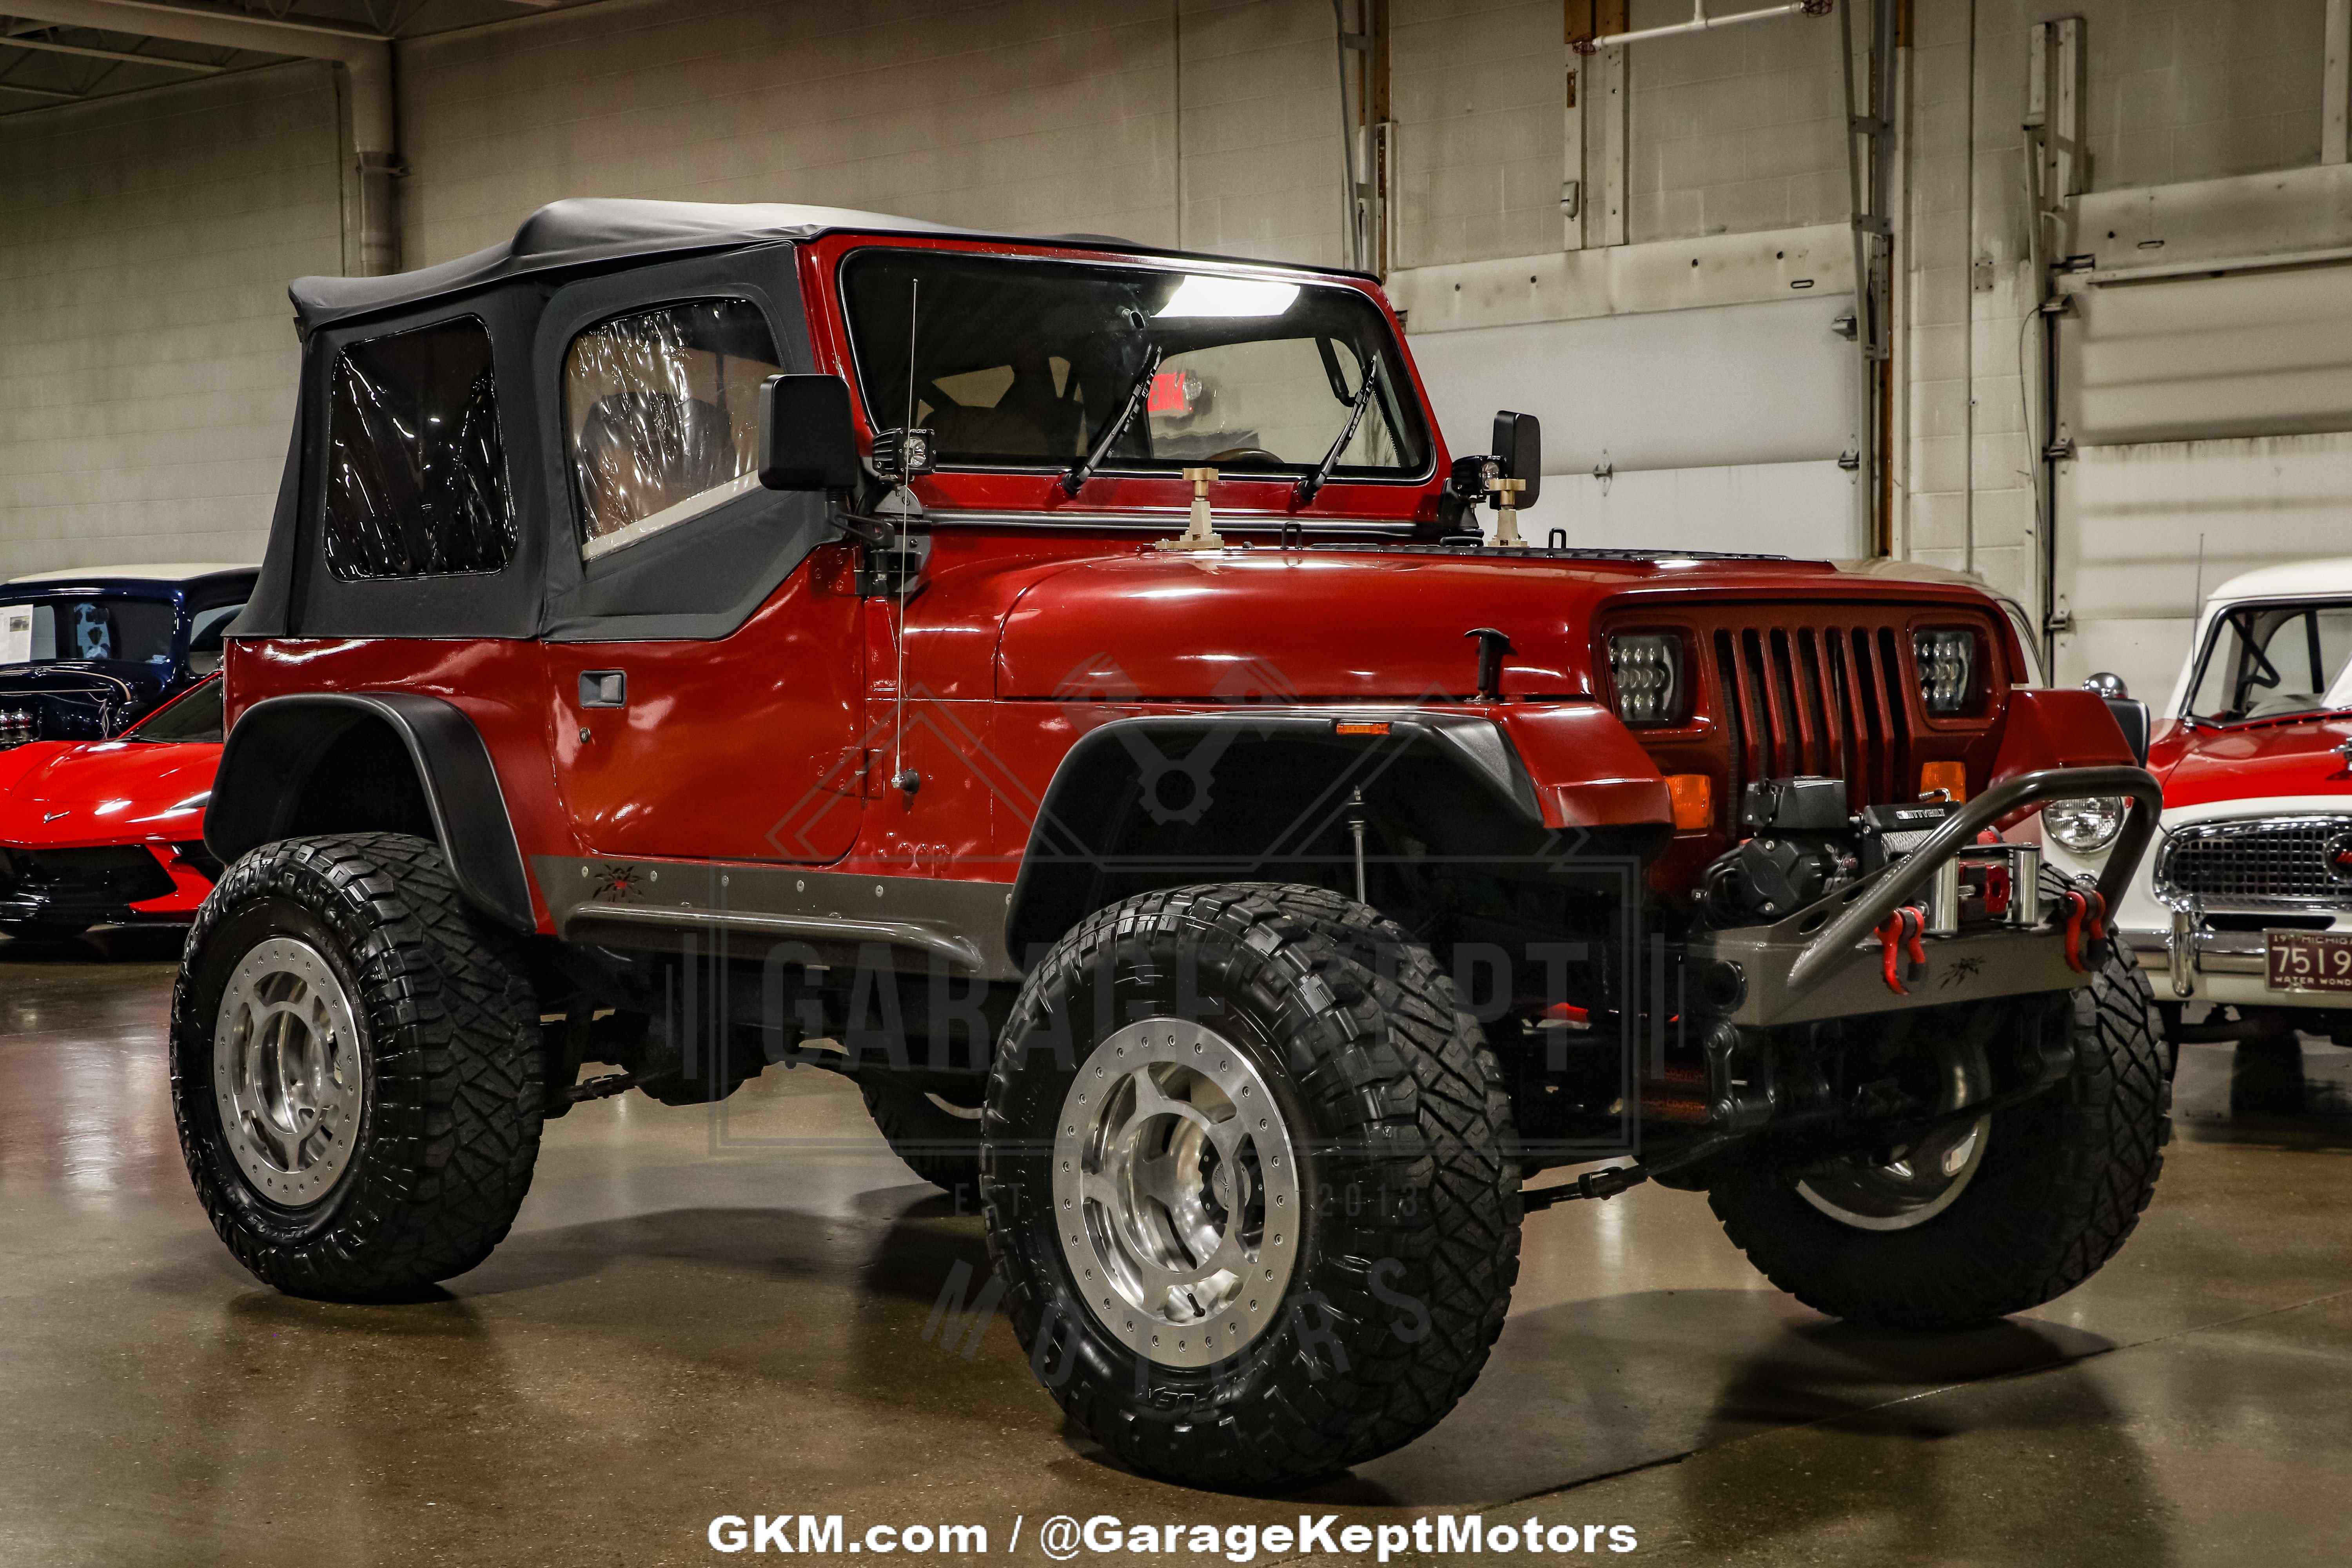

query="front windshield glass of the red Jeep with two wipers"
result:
[842,252,1430,479]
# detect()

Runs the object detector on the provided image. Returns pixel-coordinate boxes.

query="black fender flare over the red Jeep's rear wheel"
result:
[205,691,536,931]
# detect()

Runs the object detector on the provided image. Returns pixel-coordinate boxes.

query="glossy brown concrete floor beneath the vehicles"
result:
[0,938,2352,1568]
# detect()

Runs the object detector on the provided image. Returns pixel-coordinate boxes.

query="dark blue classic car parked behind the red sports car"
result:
[0,566,259,748]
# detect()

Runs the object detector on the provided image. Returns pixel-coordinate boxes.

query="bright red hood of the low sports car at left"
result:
[0,740,221,849]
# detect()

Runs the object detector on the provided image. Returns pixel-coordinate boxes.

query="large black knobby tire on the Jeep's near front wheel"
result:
[981,884,1519,1490]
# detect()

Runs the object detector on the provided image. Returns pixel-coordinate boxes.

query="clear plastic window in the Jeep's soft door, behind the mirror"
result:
[564,299,781,559]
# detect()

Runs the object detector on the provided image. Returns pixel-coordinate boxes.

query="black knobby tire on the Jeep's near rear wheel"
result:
[172,832,543,1300]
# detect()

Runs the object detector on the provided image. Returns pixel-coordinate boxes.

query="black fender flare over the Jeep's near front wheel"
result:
[1004,708,1545,964]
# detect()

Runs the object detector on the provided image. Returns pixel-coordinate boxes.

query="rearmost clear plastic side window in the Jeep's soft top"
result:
[322,318,515,581]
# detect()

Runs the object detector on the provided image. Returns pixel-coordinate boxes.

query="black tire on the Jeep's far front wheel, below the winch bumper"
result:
[1708,950,2173,1333]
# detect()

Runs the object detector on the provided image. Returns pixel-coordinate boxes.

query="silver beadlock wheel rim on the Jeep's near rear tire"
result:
[212,936,367,1208]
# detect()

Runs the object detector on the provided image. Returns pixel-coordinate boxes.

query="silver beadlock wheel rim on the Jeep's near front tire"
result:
[1054,1018,1301,1366]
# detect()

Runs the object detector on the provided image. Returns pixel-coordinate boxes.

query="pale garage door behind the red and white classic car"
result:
[2056,266,2352,701]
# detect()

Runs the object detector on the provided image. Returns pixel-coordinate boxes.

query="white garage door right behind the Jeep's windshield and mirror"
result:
[1411,294,1867,557]
